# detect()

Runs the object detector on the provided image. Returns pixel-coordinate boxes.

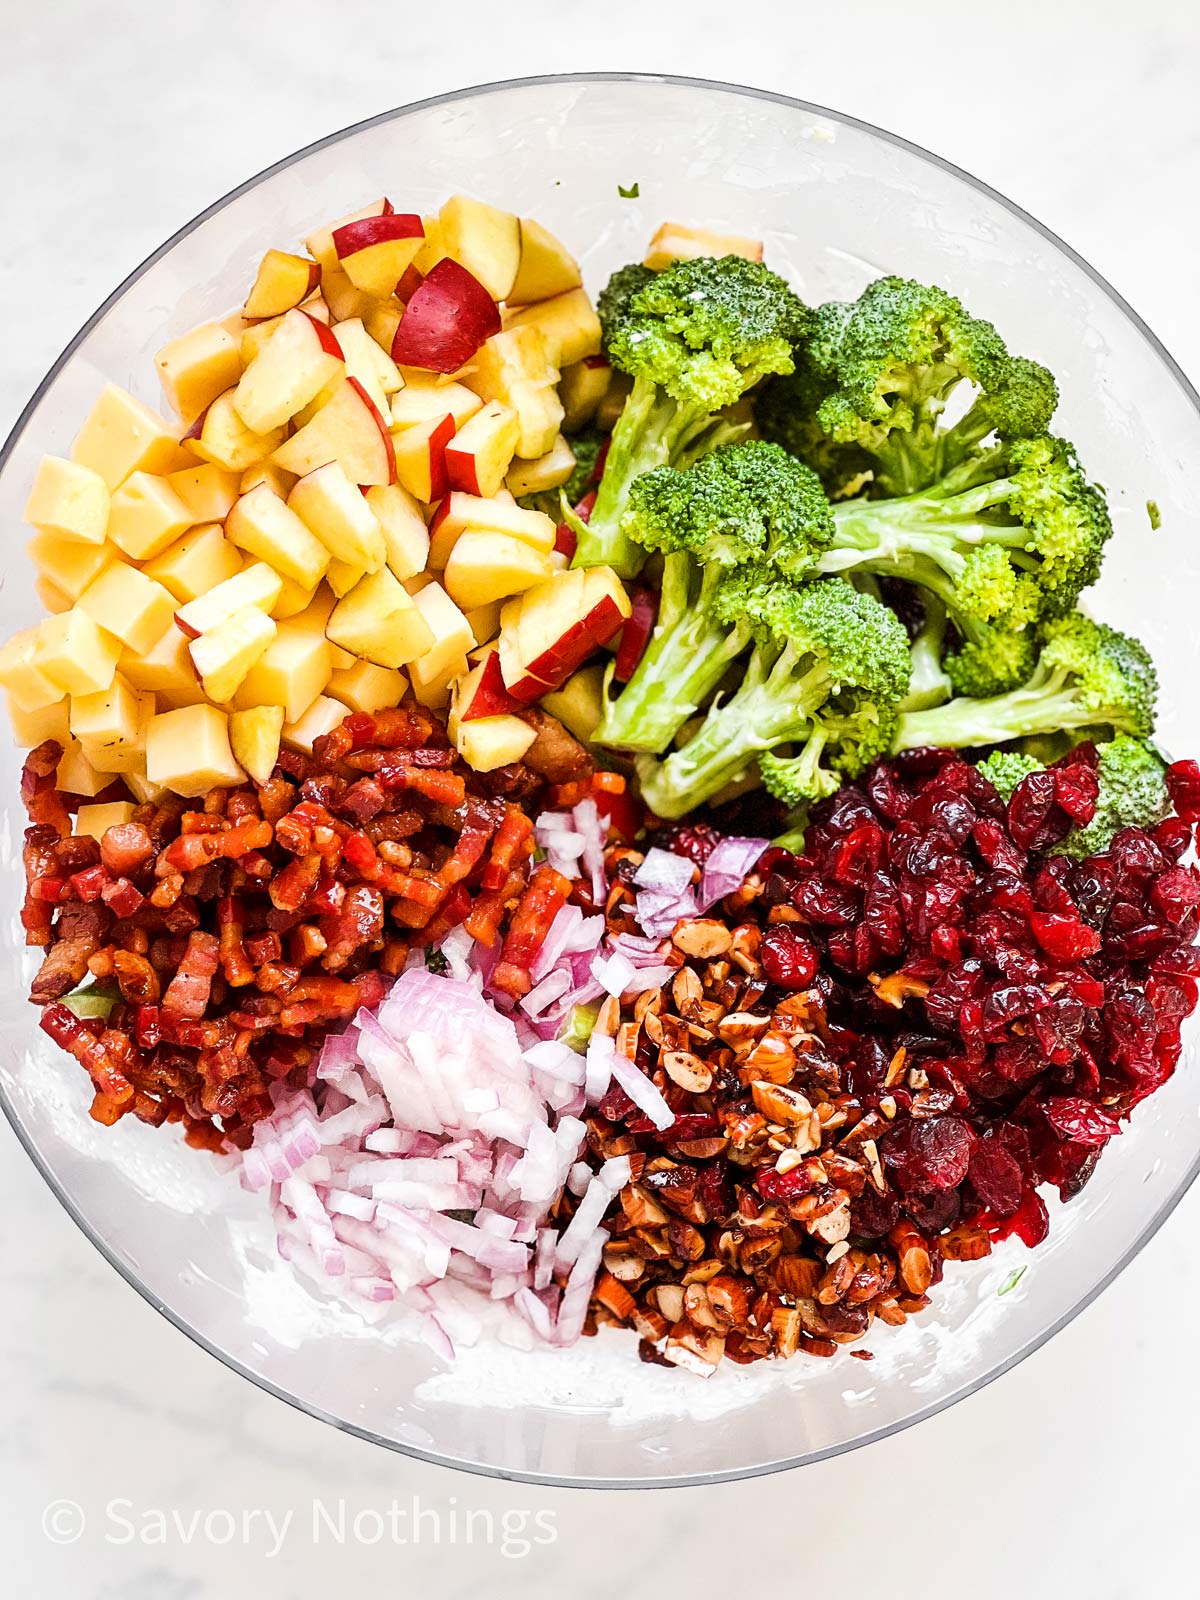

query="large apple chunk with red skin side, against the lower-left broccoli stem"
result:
[499,566,630,702]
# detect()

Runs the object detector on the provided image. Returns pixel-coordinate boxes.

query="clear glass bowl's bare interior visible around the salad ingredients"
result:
[0,74,1200,1486]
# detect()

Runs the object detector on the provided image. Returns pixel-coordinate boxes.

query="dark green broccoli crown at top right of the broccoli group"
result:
[763,277,1058,494]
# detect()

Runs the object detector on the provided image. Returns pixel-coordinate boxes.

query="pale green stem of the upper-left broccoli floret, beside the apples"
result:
[566,378,712,578]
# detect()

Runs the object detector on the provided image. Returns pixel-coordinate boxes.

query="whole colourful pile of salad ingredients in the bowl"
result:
[0,195,1200,1376]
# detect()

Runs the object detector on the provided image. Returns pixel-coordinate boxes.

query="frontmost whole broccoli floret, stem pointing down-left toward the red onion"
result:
[637,576,909,818]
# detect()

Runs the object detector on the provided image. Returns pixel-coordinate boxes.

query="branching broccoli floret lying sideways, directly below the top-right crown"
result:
[821,435,1112,629]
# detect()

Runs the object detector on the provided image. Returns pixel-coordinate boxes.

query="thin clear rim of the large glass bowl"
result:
[0,72,1200,1490]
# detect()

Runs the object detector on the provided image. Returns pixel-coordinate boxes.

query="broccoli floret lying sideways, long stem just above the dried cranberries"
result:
[893,613,1157,750]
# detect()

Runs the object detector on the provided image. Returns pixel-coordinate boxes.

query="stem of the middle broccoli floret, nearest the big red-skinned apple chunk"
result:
[592,550,750,754]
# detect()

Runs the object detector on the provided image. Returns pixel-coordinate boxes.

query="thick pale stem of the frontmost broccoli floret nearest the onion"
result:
[637,645,830,818]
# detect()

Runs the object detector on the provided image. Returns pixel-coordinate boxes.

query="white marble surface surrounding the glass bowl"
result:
[0,0,1200,1600]
